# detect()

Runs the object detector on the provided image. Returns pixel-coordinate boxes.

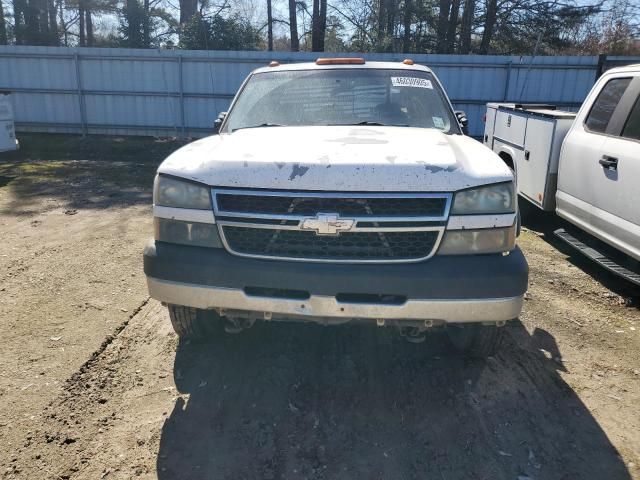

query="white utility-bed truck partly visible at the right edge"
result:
[484,65,640,286]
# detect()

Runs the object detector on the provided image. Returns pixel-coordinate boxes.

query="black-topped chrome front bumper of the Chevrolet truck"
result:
[144,242,528,323]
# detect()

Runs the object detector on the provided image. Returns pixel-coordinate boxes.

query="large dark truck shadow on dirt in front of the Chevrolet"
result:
[157,322,630,480]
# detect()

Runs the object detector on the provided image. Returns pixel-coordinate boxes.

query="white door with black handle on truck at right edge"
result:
[591,78,640,260]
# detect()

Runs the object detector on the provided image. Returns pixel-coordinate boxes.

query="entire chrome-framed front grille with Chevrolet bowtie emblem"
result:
[212,189,452,263]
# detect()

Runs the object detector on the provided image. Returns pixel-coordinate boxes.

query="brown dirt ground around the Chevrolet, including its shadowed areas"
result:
[0,135,640,480]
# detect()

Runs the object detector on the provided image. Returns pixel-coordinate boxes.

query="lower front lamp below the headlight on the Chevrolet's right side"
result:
[438,225,516,255]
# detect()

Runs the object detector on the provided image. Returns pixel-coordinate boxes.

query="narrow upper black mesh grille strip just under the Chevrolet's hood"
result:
[216,193,447,217]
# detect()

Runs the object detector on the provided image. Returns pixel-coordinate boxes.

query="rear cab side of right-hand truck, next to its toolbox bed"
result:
[556,74,632,236]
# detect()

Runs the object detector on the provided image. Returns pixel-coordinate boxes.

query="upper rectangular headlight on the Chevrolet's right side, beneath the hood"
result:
[451,182,516,215]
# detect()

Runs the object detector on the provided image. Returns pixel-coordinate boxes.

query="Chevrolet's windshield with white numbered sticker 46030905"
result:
[225,69,459,133]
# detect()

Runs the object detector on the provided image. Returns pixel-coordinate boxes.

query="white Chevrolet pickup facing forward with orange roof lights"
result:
[144,58,528,356]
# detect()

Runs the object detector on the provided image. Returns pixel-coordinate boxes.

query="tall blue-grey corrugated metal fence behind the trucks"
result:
[0,46,624,136]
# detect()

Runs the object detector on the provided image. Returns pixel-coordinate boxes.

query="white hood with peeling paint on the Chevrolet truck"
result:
[158,126,512,192]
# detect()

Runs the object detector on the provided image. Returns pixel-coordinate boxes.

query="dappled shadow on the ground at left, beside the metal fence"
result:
[0,134,183,215]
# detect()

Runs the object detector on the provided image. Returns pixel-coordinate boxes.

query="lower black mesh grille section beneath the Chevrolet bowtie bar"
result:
[222,225,438,260]
